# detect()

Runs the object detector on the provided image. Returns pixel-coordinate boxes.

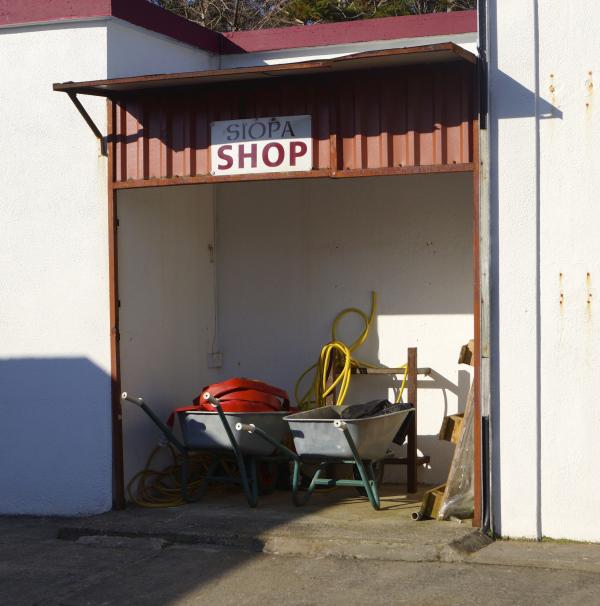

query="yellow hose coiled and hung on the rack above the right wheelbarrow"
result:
[294,292,407,409]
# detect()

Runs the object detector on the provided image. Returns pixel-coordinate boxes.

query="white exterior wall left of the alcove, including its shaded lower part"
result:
[0,19,213,514]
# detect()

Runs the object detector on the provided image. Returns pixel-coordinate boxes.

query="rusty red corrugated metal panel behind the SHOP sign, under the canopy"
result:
[114,62,474,182]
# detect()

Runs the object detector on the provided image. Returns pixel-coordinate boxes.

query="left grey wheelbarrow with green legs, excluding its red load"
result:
[121,392,290,507]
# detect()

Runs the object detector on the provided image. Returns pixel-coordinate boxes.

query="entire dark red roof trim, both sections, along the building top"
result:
[0,0,477,54]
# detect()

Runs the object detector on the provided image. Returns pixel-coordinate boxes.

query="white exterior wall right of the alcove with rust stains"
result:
[488,0,600,541]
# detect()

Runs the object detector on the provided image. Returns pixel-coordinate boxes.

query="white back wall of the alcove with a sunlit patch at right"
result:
[217,174,473,483]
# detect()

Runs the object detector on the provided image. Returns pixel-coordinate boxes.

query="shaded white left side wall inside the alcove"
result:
[117,185,218,481]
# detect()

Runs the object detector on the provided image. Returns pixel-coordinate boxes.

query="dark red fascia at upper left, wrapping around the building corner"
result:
[0,0,221,53]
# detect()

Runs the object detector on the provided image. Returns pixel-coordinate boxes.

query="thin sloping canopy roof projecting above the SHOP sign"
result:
[54,42,476,97]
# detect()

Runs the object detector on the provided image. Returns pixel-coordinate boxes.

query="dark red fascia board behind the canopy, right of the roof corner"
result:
[222,10,477,53]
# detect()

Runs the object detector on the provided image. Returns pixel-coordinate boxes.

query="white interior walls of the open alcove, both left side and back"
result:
[119,174,473,483]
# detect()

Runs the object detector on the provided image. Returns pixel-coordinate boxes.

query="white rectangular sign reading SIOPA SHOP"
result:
[210,116,312,175]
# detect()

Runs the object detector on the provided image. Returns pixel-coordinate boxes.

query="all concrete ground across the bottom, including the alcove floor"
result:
[0,491,600,606]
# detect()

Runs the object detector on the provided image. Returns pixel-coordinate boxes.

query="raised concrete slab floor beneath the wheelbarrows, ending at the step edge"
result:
[56,486,485,562]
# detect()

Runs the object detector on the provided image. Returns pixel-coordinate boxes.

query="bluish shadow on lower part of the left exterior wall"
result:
[0,358,112,515]
